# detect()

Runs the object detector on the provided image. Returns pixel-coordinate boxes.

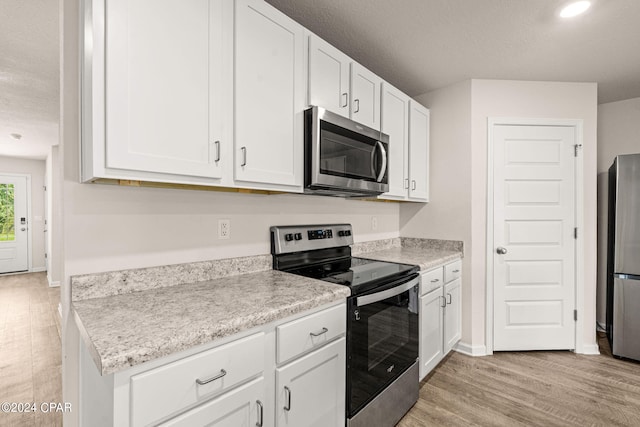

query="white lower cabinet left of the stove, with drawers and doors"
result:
[80,303,346,427]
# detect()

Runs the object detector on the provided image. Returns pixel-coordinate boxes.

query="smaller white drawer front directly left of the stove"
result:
[276,304,347,363]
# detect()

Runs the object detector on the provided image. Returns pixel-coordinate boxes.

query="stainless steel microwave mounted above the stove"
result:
[304,107,389,197]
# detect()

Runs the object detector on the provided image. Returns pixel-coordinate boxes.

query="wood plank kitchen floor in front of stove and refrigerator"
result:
[398,335,640,427]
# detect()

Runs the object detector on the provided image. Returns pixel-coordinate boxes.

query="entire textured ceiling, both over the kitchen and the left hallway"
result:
[0,0,640,158]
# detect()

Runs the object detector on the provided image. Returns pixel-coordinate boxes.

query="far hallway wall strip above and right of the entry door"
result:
[0,157,46,271]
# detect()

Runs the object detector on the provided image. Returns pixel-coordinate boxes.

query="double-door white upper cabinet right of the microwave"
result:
[379,86,429,202]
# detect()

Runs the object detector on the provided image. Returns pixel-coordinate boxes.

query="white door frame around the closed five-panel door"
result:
[485,117,585,355]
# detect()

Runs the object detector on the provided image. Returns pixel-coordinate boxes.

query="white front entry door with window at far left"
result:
[0,175,29,273]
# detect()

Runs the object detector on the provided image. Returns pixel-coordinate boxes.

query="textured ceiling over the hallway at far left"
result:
[0,0,60,159]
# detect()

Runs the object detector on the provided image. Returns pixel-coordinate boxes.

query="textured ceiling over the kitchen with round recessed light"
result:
[267,0,640,103]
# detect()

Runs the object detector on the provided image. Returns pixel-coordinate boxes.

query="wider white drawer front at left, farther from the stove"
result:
[131,332,265,426]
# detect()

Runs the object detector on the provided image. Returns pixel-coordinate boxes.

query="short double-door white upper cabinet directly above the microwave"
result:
[308,34,382,129]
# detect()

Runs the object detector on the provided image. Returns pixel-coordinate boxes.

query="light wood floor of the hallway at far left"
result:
[0,273,62,426]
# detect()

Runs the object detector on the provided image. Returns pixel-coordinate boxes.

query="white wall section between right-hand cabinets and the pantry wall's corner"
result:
[400,80,472,343]
